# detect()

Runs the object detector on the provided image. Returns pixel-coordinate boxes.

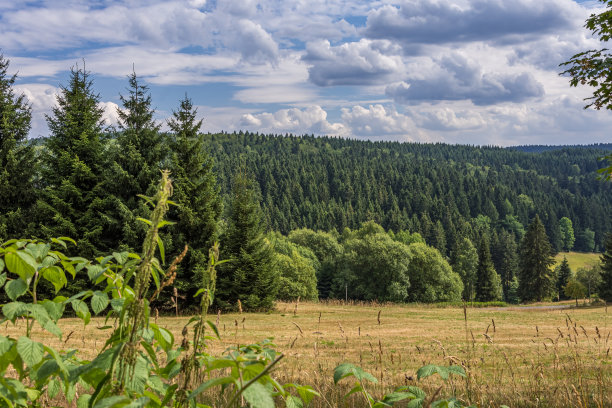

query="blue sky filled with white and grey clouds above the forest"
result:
[0,0,612,146]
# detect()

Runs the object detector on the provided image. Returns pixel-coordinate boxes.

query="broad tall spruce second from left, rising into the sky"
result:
[36,66,105,257]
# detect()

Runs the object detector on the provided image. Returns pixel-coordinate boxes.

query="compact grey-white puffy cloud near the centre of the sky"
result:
[303,39,403,86]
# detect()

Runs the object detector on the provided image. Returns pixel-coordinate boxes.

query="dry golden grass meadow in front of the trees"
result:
[6,303,612,407]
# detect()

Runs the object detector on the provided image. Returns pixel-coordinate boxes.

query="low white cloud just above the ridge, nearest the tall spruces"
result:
[239,106,345,135]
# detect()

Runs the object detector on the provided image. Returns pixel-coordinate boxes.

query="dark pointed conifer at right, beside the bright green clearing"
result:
[519,214,555,301]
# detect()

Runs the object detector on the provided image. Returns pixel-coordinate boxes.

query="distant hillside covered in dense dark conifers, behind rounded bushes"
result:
[207,132,612,254]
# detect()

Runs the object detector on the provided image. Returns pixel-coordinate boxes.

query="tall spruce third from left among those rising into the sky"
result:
[107,72,168,248]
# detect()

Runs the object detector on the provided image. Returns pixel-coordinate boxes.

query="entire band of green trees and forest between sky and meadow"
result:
[0,57,612,310]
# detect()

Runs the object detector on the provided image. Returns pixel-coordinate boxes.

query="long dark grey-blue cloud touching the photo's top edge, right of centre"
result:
[364,0,585,44]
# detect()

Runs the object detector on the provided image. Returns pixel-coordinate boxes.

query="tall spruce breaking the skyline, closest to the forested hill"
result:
[166,96,221,306]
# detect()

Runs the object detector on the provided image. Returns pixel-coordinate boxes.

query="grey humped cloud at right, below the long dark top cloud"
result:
[386,53,544,105]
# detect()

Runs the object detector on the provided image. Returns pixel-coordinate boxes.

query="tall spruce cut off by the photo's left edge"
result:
[0,54,36,240]
